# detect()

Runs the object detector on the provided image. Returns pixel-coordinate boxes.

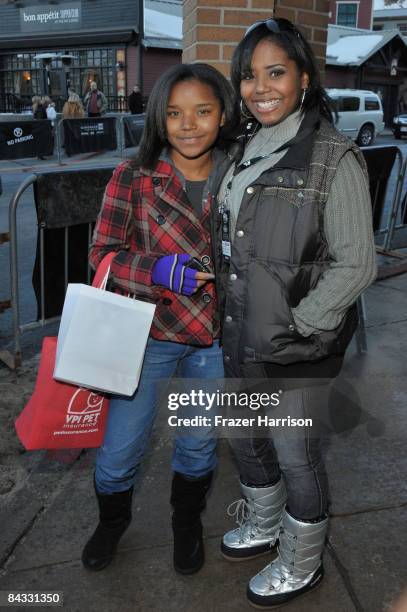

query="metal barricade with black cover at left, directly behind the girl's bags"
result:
[7,165,114,368]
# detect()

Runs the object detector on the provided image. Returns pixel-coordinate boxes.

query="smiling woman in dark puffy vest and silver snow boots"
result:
[216,19,376,608]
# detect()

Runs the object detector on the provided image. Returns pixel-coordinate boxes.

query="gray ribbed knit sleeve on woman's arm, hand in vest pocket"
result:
[292,151,377,336]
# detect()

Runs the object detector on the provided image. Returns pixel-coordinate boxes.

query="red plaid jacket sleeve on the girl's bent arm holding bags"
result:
[89,162,161,298]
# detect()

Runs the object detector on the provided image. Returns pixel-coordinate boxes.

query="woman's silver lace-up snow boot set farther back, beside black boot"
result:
[221,478,287,561]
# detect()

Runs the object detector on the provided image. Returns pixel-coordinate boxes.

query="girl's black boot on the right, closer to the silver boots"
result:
[171,472,213,574]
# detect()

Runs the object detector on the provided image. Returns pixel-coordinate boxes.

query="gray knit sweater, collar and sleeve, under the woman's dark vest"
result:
[219,112,376,336]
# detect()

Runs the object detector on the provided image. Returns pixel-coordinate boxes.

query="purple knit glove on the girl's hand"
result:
[151,253,198,295]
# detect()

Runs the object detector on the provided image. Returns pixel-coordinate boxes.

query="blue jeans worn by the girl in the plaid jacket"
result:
[95,338,224,494]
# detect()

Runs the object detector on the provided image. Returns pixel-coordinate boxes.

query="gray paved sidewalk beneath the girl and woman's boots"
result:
[0,275,407,612]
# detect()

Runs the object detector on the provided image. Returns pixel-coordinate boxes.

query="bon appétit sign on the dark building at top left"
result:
[20,2,82,32]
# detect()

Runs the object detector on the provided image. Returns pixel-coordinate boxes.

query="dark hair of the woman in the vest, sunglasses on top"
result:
[231,19,333,123]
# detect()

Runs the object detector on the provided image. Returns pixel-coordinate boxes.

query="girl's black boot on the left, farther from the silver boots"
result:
[82,487,133,572]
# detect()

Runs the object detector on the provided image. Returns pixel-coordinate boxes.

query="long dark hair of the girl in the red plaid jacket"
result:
[136,63,240,170]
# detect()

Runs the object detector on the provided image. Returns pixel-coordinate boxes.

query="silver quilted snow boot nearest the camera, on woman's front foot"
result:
[247,511,328,609]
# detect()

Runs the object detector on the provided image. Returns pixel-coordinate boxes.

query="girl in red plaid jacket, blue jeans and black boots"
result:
[82,64,239,574]
